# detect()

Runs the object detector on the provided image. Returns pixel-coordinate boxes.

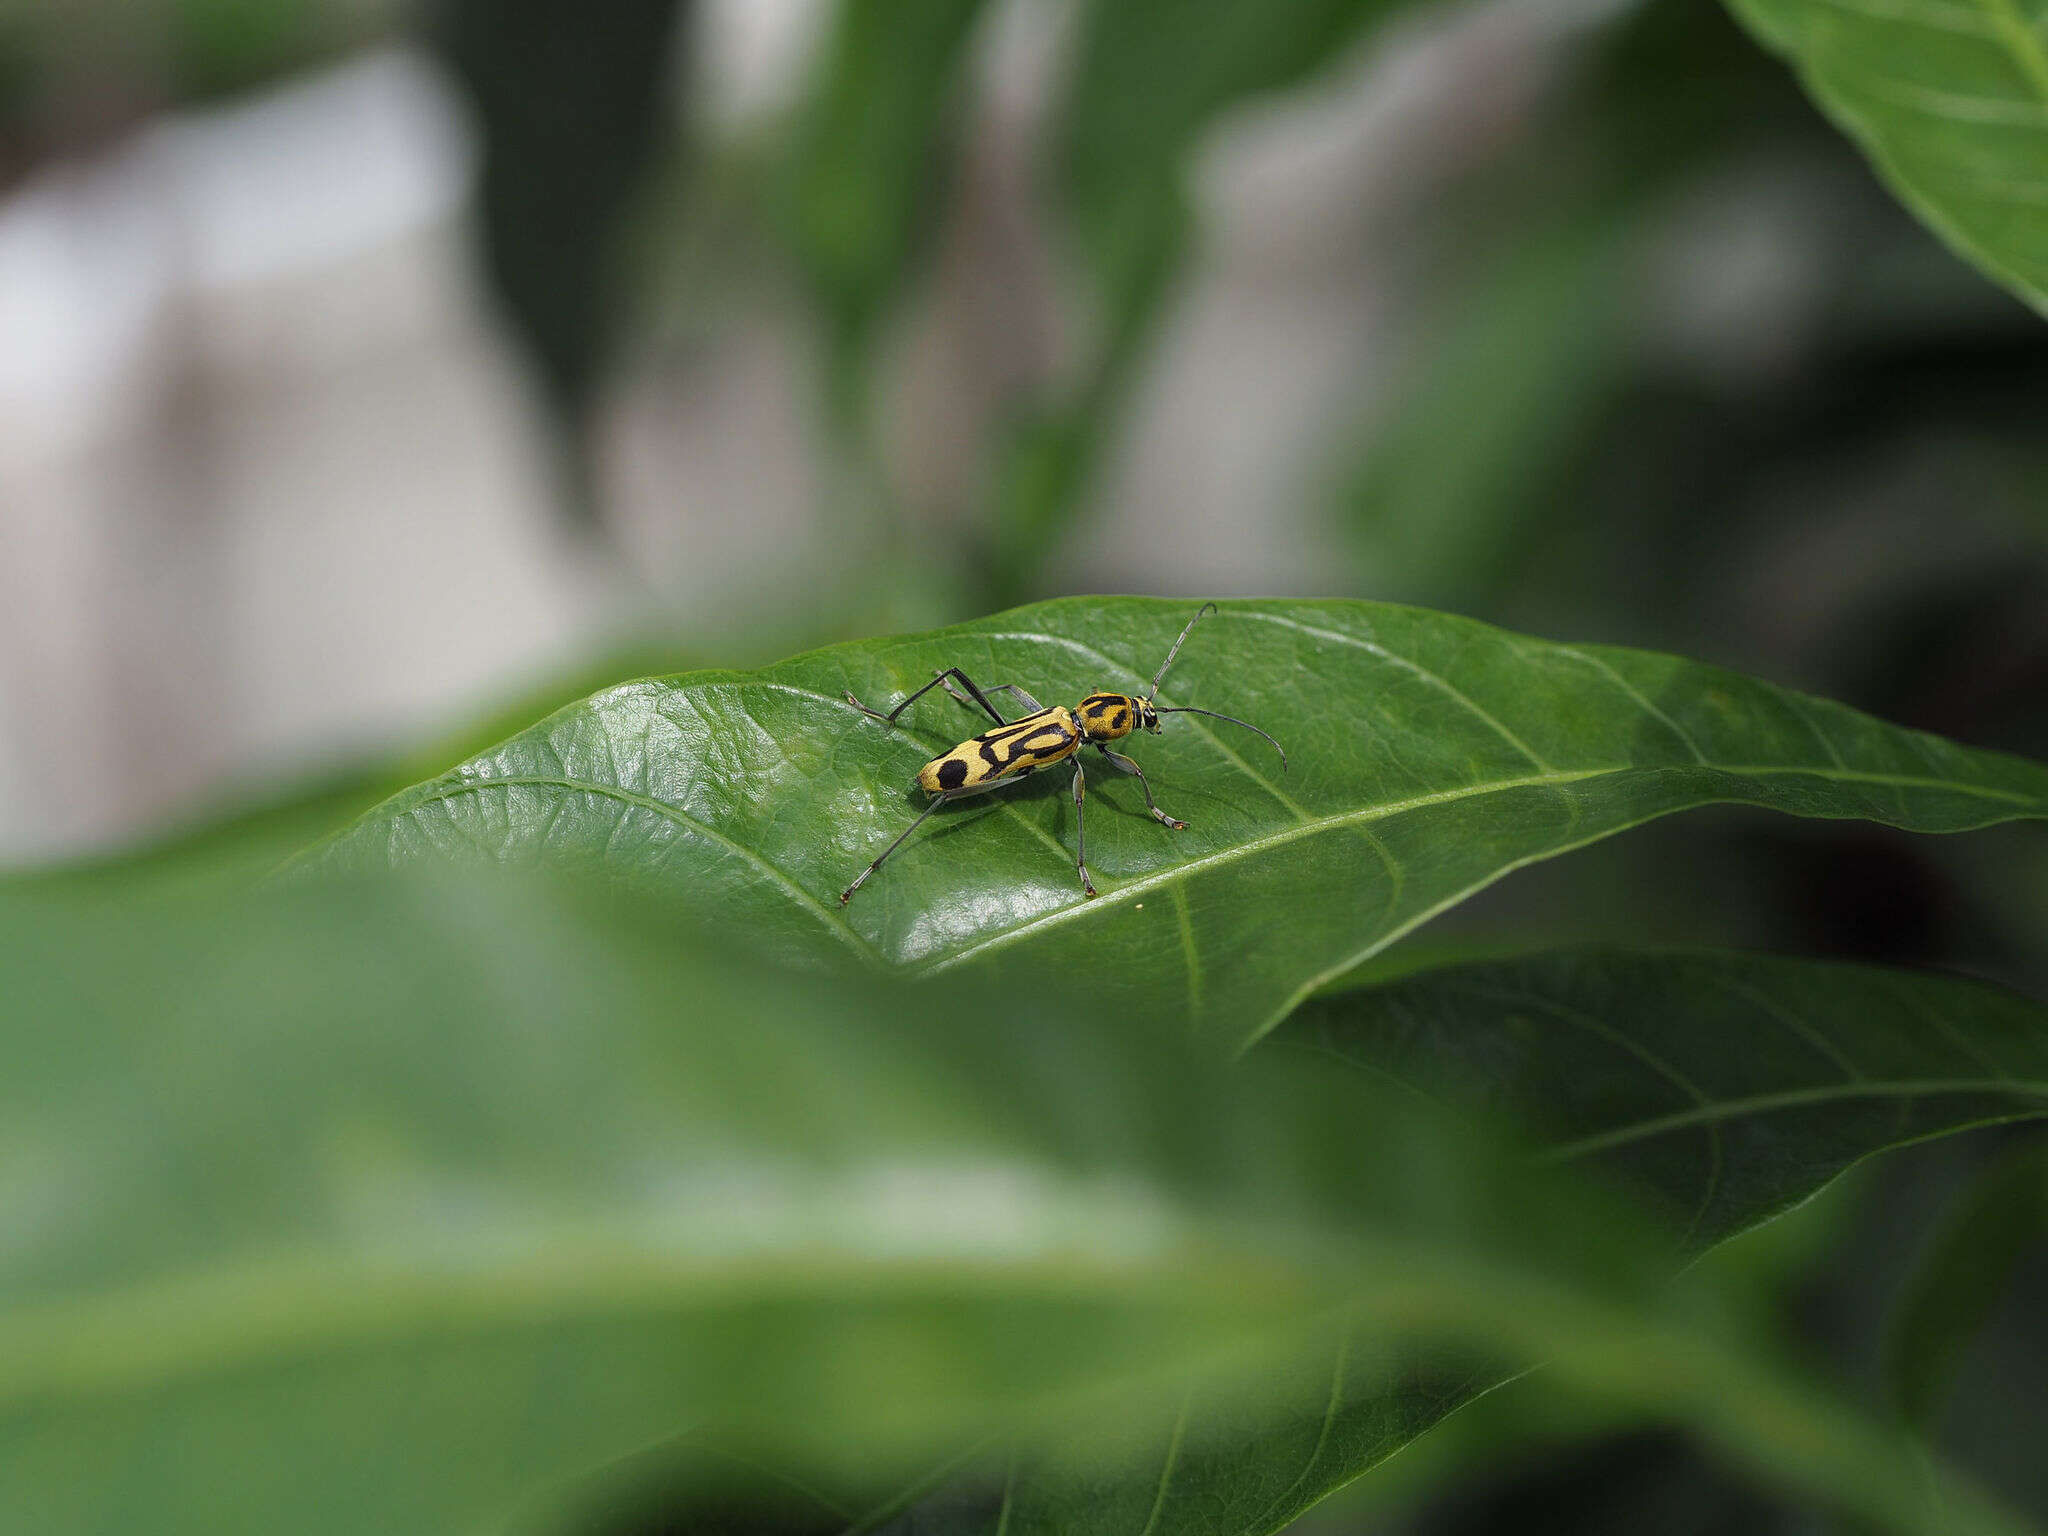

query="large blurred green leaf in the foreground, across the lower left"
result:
[0,879,2017,1536]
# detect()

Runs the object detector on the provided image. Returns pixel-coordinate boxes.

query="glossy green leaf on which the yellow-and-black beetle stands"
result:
[309,598,2048,1044]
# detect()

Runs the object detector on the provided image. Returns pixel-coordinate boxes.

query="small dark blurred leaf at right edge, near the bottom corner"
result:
[1888,1143,2048,1434]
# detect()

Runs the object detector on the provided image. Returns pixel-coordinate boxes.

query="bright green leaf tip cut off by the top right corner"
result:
[1731,0,2048,311]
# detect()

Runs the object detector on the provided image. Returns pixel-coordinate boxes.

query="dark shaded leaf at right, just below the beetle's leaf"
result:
[1270,948,2048,1253]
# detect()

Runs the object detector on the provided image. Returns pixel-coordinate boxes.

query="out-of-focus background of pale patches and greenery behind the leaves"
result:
[0,0,2048,1536]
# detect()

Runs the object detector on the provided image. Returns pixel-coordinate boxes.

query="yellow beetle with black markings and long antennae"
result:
[840,602,1286,907]
